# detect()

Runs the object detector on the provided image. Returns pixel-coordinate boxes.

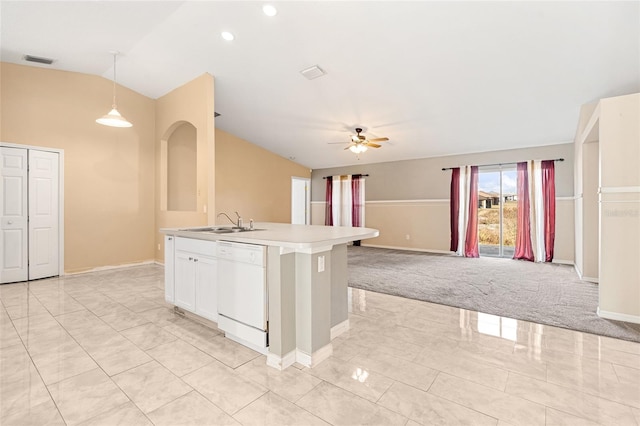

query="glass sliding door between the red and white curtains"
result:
[478,166,518,257]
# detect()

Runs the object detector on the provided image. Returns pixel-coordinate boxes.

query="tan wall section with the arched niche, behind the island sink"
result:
[155,74,215,262]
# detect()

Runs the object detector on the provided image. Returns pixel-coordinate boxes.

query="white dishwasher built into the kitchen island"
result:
[217,241,269,353]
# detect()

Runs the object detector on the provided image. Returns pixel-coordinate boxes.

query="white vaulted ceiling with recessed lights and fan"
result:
[0,0,640,169]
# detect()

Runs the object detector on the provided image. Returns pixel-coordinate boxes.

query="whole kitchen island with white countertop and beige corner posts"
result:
[161,223,379,369]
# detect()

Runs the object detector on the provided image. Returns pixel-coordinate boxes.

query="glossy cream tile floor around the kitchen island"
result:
[0,265,640,426]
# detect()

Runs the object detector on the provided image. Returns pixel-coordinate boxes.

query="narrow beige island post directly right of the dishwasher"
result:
[267,246,296,368]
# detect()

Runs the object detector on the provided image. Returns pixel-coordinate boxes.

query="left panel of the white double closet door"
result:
[0,147,28,283]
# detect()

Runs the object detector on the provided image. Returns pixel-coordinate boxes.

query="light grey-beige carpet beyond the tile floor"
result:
[348,246,640,342]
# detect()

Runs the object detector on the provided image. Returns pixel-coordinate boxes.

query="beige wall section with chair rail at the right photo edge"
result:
[598,94,640,323]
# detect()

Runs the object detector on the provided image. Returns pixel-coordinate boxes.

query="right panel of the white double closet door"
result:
[29,149,60,280]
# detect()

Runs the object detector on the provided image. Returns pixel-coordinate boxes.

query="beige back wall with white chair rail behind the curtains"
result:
[311,144,575,263]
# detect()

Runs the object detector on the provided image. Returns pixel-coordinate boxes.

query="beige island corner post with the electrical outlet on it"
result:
[296,249,331,366]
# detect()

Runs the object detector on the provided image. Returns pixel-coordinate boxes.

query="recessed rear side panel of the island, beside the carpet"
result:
[331,244,349,330]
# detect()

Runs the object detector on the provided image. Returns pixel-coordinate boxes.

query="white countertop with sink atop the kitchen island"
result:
[160,222,380,251]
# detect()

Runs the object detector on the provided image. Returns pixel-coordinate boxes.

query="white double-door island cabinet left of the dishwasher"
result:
[165,236,218,322]
